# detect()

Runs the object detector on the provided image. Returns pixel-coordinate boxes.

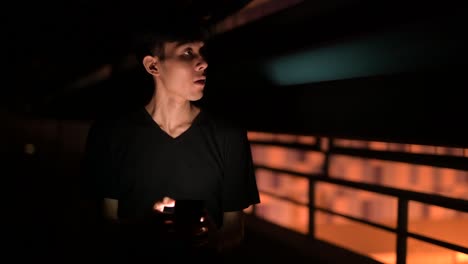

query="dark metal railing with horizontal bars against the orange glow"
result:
[251,138,468,264]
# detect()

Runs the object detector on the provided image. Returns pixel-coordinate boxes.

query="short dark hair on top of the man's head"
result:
[133,18,210,62]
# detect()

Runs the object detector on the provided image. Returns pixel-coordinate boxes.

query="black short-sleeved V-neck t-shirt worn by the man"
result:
[83,107,260,226]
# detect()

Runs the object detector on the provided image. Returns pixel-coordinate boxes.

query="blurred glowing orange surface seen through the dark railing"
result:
[250,133,468,264]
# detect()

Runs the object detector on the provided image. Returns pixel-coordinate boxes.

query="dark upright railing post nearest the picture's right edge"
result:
[396,197,408,264]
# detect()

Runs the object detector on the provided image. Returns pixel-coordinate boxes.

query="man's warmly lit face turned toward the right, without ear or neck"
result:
[158,42,208,101]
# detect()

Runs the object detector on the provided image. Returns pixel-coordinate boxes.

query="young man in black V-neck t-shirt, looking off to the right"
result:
[83,17,260,260]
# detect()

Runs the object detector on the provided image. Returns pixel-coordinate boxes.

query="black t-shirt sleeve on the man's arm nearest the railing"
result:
[223,125,260,212]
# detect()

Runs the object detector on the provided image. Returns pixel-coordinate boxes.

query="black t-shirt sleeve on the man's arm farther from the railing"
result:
[81,122,119,199]
